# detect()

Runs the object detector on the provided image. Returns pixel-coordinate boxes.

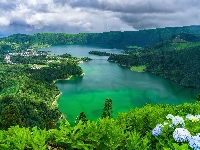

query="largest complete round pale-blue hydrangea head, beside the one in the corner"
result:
[173,128,191,142]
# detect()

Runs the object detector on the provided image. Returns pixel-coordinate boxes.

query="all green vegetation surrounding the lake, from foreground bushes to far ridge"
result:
[0,26,200,150]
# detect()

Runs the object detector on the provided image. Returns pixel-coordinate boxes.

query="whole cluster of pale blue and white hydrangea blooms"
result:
[152,114,200,150]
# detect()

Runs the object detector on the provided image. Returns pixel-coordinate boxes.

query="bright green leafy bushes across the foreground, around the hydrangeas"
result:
[0,102,200,150]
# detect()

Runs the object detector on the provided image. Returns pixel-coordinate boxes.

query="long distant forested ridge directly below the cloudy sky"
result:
[0,26,200,50]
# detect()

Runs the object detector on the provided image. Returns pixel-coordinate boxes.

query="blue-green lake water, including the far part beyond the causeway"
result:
[39,45,200,125]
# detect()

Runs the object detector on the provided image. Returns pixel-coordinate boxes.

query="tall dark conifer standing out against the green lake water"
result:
[101,98,113,118]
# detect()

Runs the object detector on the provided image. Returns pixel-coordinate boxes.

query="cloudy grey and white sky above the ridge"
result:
[0,0,200,35]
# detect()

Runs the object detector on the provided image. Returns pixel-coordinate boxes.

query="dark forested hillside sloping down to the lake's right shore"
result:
[108,34,200,88]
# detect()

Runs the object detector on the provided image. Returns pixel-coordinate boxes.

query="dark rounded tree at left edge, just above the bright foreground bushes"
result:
[1,104,22,130]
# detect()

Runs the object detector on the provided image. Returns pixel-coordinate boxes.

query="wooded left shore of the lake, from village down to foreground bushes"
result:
[0,55,82,129]
